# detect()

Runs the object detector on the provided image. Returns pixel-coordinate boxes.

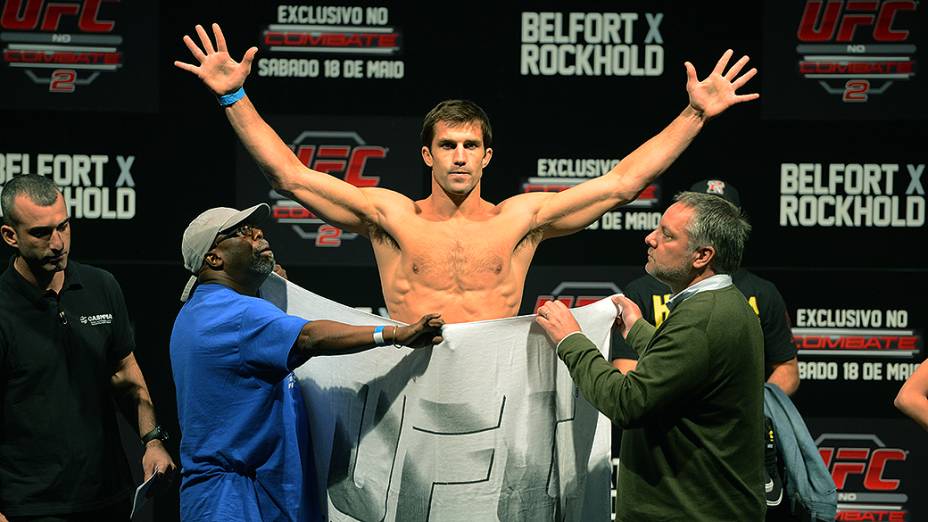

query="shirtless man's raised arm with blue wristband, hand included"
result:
[174,24,380,235]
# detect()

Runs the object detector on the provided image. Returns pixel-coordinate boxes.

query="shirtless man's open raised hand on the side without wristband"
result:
[683,49,760,120]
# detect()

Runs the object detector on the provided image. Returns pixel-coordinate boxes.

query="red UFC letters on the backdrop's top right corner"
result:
[797,0,916,42]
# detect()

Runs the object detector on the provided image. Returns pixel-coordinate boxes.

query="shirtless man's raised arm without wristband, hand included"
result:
[533,49,759,238]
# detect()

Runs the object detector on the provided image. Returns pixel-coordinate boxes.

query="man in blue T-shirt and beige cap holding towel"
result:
[171,204,443,521]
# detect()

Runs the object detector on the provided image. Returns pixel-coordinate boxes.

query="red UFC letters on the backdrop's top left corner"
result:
[0,0,118,33]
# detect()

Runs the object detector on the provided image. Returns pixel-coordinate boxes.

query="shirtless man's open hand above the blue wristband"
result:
[174,24,258,96]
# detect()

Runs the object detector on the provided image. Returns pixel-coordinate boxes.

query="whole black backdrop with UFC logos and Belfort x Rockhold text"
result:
[0,0,928,520]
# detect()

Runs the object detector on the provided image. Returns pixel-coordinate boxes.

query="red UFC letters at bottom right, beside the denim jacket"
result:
[818,448,906,491]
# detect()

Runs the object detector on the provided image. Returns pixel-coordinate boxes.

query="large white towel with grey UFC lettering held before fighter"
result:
[262,276,616,522]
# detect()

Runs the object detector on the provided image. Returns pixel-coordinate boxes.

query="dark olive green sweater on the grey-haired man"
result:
[558,286,766,521]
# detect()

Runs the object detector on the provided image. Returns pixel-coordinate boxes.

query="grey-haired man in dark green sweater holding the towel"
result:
[537,192,766,521]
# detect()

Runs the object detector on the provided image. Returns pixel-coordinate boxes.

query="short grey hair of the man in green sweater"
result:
[674,192,751,274]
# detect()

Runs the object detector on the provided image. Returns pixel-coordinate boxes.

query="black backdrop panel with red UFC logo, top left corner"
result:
[0,0,159,112]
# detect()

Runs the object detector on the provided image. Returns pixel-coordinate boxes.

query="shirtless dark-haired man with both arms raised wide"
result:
[174,24,759,323]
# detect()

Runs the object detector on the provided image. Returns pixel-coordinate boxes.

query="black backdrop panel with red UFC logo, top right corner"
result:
[763,0,928,120]
